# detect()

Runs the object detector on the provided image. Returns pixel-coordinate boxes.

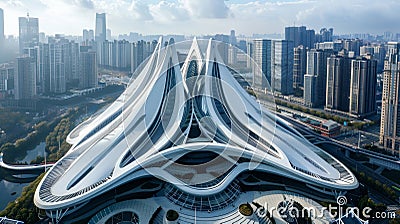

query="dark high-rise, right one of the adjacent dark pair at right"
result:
[349,58,377,117]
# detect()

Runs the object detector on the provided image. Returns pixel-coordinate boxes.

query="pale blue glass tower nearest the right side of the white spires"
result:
[253,39,272,89]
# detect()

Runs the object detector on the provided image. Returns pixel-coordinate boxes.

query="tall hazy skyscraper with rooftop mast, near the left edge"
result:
[18,14,39,54]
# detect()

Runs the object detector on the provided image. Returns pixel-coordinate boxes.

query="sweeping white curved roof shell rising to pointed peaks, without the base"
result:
[34,39,358,221]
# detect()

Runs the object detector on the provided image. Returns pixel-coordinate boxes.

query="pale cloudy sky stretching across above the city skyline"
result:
[0,0,400,35]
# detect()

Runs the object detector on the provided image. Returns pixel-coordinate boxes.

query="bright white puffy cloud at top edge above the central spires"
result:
[179,0,231,18]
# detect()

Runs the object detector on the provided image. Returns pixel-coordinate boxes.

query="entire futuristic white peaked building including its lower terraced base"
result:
[34,39,358,223]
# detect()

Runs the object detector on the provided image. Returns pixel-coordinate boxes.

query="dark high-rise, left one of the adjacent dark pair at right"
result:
[325,56,351,112]
